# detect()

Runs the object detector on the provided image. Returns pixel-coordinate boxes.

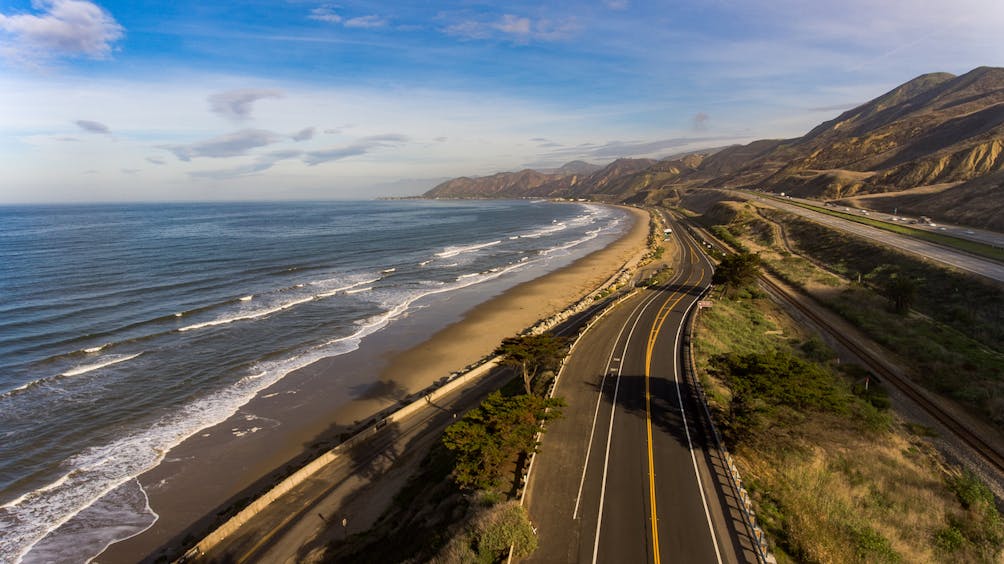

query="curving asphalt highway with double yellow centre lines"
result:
[525,219,755,564]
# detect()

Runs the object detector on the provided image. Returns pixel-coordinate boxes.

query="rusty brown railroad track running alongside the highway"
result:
[691,217,1004,473]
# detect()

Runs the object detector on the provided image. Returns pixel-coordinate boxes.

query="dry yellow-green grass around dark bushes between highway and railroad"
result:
[695,289,1001,563]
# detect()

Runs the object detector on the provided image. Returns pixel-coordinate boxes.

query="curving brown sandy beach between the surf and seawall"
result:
[96,203,648,562]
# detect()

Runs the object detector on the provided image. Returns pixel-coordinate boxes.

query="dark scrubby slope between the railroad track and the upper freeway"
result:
[714,202,1004,430]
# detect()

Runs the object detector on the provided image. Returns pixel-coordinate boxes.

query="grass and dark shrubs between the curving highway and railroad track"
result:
[694,274,1004,563]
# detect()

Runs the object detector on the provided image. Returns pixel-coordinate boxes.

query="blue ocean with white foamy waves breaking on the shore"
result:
[0,201,630,562]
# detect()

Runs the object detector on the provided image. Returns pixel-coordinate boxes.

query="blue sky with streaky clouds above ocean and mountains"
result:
[0,0,1004,204]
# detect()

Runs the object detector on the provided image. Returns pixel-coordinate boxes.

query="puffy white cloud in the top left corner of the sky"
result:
[0,0,124,64]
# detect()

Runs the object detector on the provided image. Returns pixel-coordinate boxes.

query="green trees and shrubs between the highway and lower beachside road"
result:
[324,333,568,564]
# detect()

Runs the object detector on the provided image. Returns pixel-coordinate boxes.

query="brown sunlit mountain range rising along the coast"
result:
[424,67,1004,231]
